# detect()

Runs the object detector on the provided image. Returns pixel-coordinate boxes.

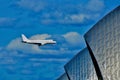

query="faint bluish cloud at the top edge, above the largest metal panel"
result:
[87,0,105,11]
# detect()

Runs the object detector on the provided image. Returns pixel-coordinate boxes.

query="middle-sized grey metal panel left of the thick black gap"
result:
[65,48,98,80]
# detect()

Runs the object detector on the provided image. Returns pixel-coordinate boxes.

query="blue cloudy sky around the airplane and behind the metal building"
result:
[0,0,120,80]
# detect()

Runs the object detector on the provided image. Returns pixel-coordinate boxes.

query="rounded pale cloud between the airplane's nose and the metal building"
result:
[63,32,84,46]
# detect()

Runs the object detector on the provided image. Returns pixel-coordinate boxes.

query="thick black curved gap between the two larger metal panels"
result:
[85,40,103,80]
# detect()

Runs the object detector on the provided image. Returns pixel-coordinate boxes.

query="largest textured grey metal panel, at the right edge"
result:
[85,6,120,80]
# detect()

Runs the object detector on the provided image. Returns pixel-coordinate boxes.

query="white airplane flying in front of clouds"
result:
[21,34,56,46]
